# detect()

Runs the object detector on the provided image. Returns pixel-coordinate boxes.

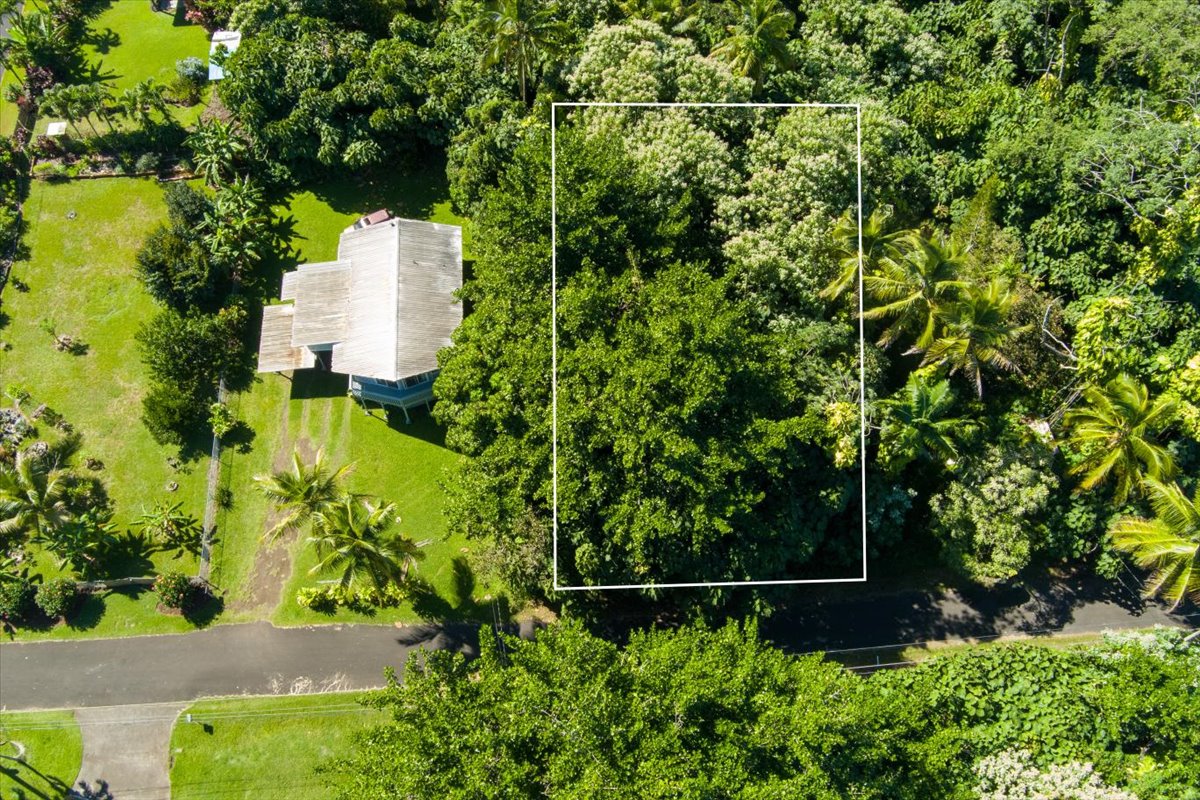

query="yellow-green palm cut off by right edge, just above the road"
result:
[1109,477,1200,609]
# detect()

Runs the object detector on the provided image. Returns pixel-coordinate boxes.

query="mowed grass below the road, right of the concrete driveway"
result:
[170,694,388,800]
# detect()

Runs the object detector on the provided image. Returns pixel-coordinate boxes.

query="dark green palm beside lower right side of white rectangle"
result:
[878,372,972,475]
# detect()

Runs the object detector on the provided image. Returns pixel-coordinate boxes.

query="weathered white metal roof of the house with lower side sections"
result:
[258,219,462,380]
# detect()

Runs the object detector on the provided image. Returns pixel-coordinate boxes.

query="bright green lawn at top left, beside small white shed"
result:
[84,0,209,91]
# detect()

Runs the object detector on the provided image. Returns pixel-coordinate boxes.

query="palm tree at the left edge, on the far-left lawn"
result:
[0,452,70,539]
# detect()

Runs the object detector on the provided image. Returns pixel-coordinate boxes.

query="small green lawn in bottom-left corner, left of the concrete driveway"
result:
[0,711,83,800]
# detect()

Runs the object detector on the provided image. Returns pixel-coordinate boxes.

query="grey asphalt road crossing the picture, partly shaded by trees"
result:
[0,578,1200,709]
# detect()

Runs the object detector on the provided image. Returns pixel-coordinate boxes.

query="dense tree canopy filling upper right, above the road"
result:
[205,0,1200,594]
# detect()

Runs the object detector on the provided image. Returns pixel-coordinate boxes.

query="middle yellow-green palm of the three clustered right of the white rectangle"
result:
[863,226,965,353]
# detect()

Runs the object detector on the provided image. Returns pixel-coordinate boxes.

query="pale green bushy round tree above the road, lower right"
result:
[929,443,1058,583]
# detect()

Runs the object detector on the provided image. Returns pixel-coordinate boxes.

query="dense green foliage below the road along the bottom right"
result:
[331,624,1200,800]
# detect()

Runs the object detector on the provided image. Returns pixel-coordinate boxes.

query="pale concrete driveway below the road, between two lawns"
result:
[76,703,186,800]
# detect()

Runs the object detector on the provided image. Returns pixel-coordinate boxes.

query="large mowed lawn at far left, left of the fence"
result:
[0,179,206,638]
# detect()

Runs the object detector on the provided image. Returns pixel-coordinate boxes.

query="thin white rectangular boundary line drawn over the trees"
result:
[550,102,866,591]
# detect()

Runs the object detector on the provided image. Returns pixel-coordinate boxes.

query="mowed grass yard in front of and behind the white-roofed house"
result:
[254,163,496,625]
